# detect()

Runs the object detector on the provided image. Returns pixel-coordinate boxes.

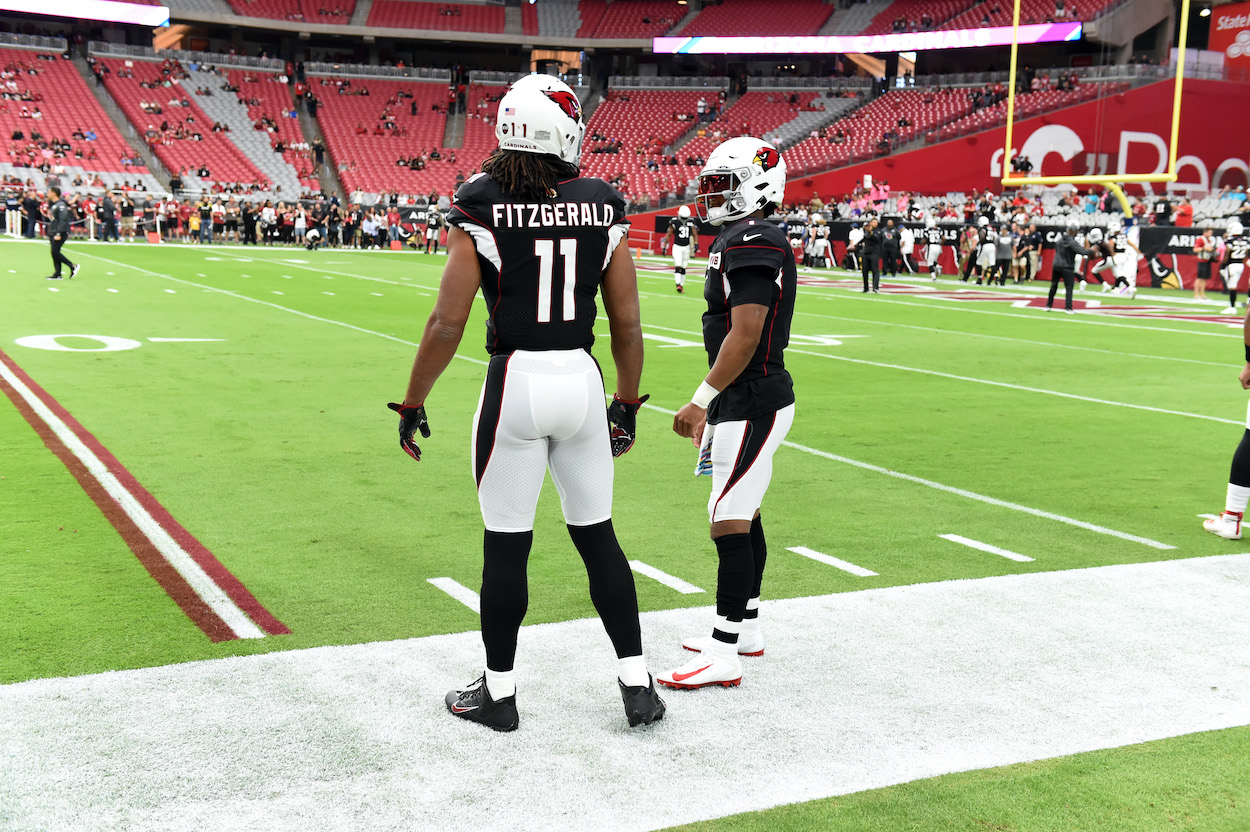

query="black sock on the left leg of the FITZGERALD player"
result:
[481,530,534,672]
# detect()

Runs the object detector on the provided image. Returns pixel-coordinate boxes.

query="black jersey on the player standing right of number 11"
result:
[703,214,799,425]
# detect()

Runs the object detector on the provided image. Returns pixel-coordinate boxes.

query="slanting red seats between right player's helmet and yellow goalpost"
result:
[786,90,973,171]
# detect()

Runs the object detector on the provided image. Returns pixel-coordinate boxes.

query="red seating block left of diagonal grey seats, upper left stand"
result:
[100,57,269,190]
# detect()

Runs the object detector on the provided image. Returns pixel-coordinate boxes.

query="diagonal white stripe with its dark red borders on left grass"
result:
[0,350,290,642]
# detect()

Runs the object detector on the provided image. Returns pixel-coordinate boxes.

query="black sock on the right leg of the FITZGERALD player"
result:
[569,520,643,658]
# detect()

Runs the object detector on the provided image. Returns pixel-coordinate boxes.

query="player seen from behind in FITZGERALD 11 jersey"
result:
[390,76,665,731]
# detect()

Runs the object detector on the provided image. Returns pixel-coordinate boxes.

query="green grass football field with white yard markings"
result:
[0,234,1250,831]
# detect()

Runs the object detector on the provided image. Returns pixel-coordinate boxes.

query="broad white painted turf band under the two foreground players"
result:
[0,555,1250,832]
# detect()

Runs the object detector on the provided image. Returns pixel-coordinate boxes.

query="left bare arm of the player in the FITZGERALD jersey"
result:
[404,227,481,406]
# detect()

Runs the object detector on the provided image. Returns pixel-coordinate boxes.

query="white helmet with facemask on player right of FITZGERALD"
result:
[695,136,785,225]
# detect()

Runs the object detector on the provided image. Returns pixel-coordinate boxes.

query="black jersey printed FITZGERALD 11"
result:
[448,174,629,355]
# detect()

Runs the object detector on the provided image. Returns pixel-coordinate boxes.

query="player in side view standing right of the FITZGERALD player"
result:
[656,136,798,688]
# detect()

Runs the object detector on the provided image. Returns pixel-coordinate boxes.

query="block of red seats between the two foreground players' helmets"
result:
[581,90,716,201]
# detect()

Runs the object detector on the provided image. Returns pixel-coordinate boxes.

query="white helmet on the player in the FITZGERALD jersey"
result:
[495,75,586,165]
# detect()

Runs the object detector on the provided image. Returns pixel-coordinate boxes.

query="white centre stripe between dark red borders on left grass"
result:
[0,362,265,638]
